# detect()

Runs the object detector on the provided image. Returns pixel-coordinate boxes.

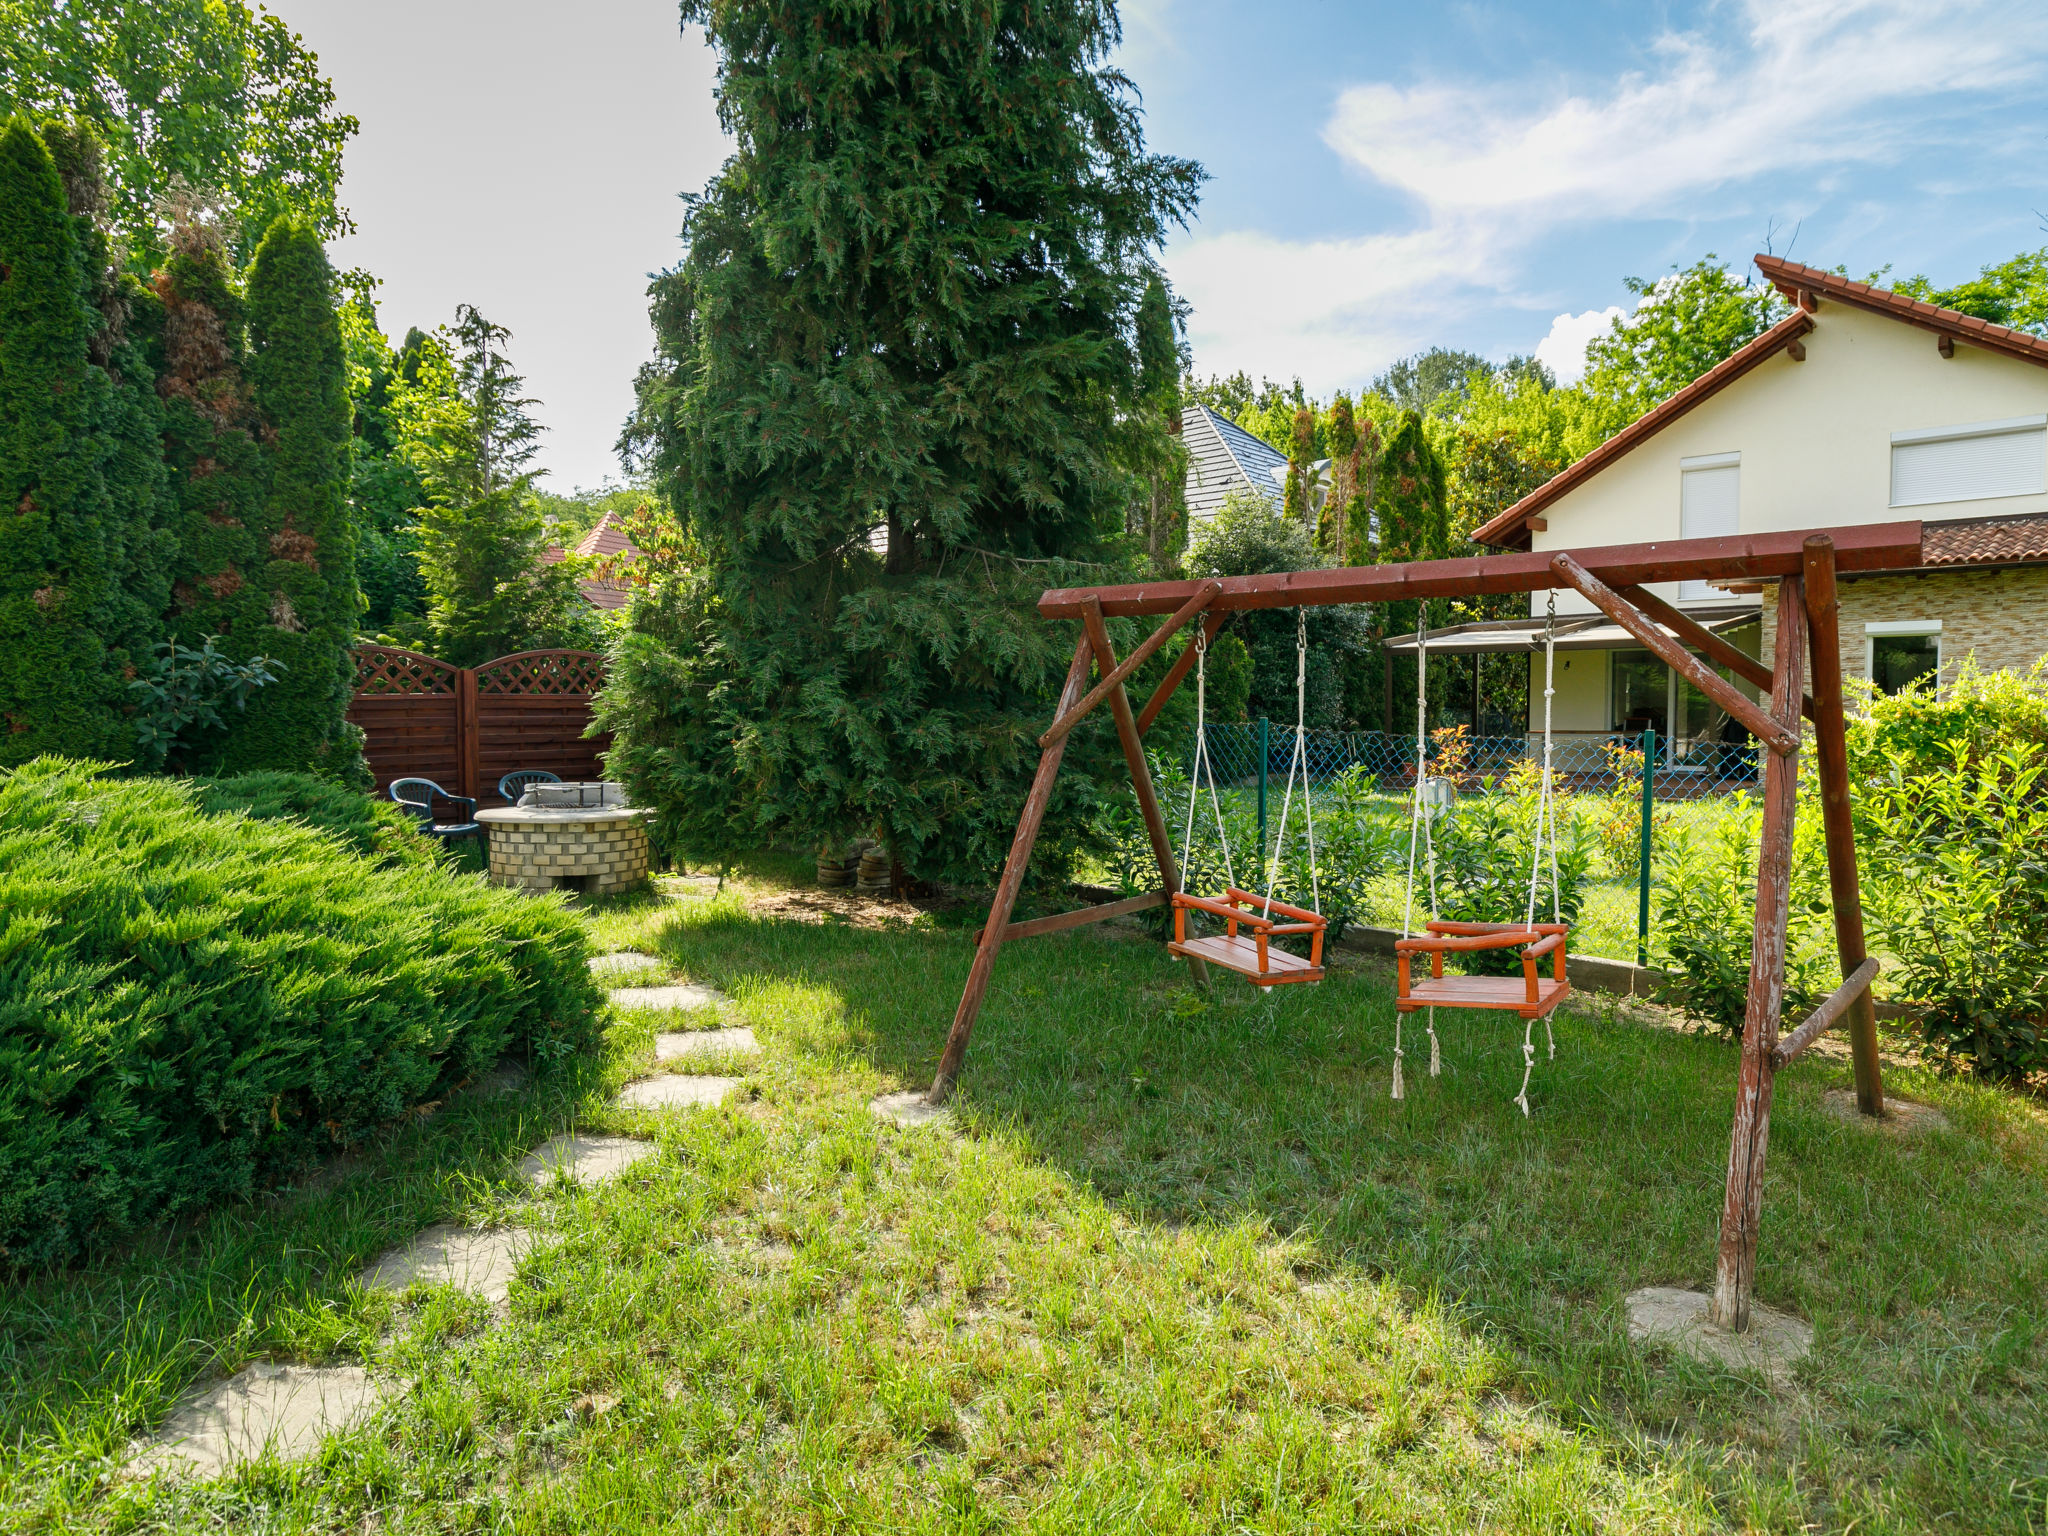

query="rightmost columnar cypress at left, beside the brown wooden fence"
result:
[209,219,365,782]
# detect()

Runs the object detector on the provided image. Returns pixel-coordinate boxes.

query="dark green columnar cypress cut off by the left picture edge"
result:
[0,119,133,764]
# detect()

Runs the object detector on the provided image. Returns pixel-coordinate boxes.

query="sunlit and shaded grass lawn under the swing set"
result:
[0,862,2048,1534]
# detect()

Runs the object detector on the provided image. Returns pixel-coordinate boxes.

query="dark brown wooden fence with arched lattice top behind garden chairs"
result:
[348,645,612,805]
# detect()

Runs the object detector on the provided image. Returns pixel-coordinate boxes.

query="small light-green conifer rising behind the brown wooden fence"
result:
[393,305,580,666]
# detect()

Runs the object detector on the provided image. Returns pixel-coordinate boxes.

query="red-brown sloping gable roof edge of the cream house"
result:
[1473,256,2048,549]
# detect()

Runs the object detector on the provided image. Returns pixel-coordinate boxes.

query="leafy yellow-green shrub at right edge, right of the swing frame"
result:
[1855,735,2048,1081]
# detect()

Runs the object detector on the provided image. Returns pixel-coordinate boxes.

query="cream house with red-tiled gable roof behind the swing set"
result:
[1392,256,2048,756]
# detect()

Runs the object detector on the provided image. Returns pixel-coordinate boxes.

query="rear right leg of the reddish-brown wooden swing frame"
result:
[1806,532,1884,1114]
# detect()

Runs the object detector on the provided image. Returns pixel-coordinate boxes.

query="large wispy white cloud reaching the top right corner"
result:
[1169,0,2048,397]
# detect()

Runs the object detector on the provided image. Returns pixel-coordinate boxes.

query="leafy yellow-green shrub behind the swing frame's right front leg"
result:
[1651,795,1837,1036]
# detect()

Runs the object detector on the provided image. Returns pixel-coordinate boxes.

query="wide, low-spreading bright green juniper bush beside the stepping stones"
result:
[0,758,600,1266]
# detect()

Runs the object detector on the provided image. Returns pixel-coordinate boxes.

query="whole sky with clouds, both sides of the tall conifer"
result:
[270,0,2048,489]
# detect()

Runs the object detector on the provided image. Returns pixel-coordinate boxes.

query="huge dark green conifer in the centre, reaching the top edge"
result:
[612,0,1200,879]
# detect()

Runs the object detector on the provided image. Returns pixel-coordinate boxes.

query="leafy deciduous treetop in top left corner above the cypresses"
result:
[0,0,356,272]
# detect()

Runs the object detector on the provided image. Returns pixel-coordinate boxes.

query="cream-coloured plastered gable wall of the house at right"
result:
[1532,301,2048,612]
